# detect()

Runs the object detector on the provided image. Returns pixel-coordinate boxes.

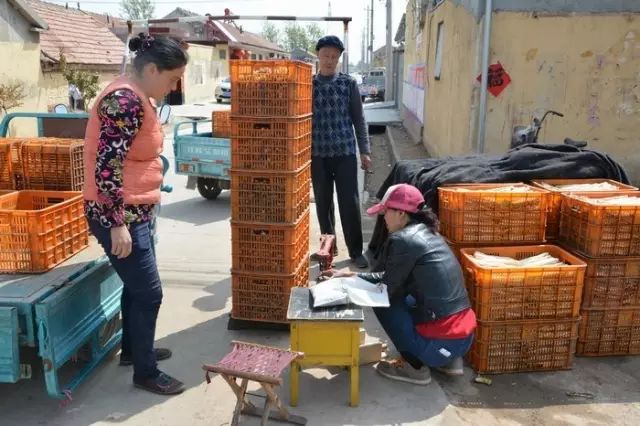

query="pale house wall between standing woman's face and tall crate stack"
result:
[184,44,229,104]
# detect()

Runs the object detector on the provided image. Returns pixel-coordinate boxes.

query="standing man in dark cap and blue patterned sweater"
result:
[311,36,371,268]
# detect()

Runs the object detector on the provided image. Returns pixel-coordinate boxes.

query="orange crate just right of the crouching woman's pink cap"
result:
[438,183,549,244]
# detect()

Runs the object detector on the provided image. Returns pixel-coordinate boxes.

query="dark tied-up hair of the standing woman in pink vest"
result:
[129,33,189,72]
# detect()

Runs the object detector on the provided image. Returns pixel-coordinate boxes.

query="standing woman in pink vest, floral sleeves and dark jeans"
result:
[83,33,188,395]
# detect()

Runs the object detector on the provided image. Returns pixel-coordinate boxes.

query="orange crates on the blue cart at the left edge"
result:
[0,138,89,273]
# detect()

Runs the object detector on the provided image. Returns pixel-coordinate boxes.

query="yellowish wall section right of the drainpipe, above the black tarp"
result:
[484,12,640,183]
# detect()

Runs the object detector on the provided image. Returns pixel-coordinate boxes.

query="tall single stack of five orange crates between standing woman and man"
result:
[230,60,312,323]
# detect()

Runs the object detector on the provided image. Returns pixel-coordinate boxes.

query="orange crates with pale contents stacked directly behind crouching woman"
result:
[439,183,585,373]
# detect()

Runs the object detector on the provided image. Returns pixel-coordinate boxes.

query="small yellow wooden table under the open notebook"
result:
[287,287,364,407]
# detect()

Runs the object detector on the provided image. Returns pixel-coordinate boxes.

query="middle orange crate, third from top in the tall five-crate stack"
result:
[230,163,311,223]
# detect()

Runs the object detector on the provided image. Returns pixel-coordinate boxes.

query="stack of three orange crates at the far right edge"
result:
[560,190,640,356]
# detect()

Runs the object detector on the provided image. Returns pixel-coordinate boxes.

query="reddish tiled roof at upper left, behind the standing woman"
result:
[28,0,124,68]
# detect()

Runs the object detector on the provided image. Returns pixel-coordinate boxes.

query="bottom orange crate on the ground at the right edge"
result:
[576,309,640,356]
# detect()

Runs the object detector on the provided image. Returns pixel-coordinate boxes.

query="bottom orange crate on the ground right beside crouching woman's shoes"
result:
[467,319,579,374]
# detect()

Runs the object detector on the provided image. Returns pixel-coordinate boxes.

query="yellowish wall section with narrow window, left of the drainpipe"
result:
[423,2,480,156]
